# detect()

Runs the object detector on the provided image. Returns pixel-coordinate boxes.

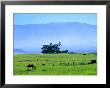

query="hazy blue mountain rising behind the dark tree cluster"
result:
[14,22,97,53]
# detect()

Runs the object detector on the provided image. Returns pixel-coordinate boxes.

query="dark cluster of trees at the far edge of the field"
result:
[41,42,68,54]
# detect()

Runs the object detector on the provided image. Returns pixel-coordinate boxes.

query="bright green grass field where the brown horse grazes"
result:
[13,53,97,75]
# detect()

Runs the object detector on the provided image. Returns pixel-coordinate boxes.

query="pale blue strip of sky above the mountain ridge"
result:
[14,13,97,25]
